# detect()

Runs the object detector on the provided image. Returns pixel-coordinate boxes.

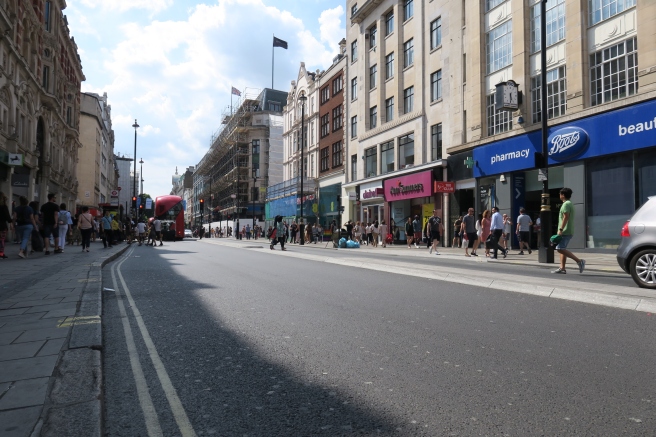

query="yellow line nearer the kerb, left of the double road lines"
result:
[111,258,164,437]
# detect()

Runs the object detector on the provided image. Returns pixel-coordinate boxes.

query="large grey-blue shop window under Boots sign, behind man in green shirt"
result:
[588,154,635,248]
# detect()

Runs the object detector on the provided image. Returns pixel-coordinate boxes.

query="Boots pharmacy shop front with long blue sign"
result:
[473,99,656,249]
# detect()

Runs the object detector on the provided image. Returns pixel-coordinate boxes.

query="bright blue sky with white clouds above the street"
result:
[63,0,346,197]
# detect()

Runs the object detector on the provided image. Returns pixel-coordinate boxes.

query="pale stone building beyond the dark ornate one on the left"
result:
[77,93,116,211]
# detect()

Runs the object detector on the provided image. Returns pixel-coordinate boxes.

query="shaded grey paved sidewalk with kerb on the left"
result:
[0,242,129,437]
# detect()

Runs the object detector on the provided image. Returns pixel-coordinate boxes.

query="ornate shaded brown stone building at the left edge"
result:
[0,0,85,209]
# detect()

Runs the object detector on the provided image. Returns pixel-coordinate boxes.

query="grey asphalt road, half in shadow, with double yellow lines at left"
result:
[103,241,656,436]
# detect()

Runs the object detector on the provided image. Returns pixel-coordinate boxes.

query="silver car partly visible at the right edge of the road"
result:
[617,196,656,290]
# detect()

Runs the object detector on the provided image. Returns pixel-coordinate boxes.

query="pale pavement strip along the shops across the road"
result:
[217,238,624,274]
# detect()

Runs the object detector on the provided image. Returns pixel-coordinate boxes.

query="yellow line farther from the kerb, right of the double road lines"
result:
[117,248,196,437]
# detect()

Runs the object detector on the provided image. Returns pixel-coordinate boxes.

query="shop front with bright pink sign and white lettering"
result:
[383,170,442,241]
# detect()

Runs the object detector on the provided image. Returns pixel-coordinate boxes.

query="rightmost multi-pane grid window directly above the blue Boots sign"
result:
[590,37,638,106]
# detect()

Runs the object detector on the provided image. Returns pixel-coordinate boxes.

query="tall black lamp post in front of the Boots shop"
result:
[538,0,554,264]
